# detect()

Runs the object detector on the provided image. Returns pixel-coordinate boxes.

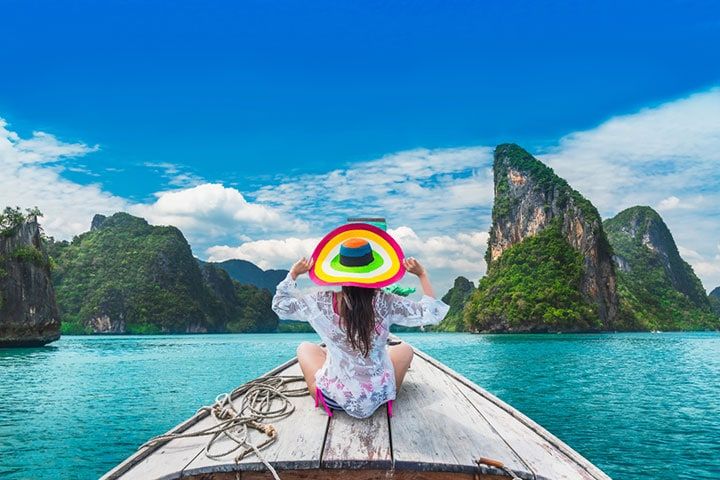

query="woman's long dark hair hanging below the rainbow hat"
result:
[339,287,377,357]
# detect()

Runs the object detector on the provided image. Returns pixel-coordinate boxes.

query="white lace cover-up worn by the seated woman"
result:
[272,275,450,418]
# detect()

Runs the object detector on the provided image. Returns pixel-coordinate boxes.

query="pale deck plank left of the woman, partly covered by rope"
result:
[183,364,328,476]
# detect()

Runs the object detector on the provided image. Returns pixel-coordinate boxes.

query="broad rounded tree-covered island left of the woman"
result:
[50,213,277,333]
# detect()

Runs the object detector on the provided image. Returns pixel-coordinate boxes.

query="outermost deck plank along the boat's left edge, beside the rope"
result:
[101,358,299,480]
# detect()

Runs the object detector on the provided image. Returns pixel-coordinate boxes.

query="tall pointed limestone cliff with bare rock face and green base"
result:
[465,144,618,331]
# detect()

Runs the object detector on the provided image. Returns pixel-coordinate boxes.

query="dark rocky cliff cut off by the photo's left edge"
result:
[0,214,60,347]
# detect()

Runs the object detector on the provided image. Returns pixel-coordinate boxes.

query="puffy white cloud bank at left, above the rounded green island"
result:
[0,118,307,248]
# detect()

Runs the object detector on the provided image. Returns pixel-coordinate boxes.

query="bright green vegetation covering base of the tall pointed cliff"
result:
[464,221,602,332]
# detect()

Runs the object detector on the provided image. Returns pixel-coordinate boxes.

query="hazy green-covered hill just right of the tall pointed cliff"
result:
[604,206,720,330]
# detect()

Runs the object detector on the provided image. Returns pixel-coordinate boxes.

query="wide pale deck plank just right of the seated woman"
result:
[390,357,533,478]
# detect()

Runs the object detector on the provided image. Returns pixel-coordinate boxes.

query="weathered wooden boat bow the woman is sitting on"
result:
[103,349,610,480]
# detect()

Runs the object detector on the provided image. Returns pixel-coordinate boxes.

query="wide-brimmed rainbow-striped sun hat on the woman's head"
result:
[309,223,405,288]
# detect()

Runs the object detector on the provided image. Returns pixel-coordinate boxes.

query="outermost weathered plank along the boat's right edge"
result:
[415,349,611,480]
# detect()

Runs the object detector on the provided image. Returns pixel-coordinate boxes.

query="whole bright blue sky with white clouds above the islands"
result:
[0,1,720,288]
